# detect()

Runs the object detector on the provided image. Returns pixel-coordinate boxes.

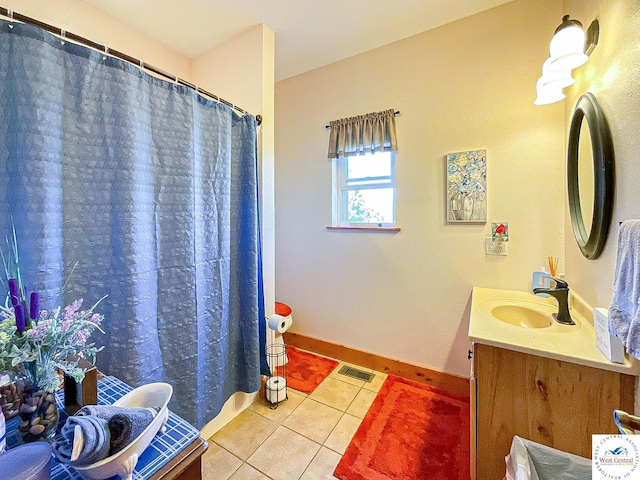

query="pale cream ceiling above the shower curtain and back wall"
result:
[82,0,512,80]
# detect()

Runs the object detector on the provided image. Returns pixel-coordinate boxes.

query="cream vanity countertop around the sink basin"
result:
[469,287,640,376]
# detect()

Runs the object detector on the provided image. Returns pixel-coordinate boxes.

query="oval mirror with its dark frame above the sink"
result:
[567,93,614,260]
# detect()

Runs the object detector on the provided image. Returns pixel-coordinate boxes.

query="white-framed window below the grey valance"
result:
[333,152,396,227]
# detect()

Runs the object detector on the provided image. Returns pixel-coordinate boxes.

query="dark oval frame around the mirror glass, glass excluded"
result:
[567,92,615,260]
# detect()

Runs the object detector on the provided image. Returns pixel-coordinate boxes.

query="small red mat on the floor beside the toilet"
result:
[278,346,338,393]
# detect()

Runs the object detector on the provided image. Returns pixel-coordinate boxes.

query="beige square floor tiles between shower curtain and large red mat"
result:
[202,352,387,480]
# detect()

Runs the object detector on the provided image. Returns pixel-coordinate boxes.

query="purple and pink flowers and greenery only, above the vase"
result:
[0,228,105,392]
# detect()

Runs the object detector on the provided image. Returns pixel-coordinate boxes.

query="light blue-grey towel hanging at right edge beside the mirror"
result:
[609,220,640,358]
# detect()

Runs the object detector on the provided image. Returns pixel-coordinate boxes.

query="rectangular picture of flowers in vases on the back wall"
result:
[446,150,487,223]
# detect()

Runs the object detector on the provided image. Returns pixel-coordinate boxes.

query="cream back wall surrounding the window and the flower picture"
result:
[276,0,565,376]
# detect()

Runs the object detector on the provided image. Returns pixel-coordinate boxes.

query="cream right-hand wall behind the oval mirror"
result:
[564,0,640,307]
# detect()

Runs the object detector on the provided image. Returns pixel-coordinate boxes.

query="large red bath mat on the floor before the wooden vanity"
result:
[333,375,470,480]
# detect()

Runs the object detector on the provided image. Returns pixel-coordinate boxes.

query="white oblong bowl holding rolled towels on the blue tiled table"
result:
[74,383,173,480]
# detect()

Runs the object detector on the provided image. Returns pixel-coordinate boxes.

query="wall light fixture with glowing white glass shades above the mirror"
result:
[533,15,600,105]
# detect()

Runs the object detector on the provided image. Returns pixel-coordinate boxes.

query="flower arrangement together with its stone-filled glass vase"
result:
[0,227,105,442]
